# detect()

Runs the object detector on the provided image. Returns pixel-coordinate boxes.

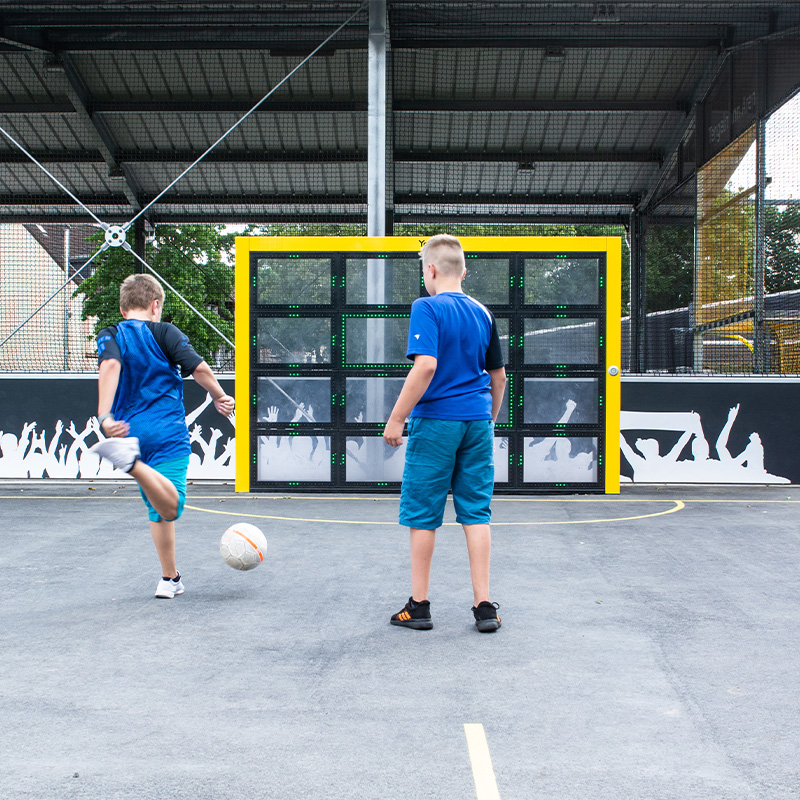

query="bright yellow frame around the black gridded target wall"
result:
[235,236,622,494]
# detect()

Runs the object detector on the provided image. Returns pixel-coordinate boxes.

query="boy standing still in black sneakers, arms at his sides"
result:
[383,234,506,632]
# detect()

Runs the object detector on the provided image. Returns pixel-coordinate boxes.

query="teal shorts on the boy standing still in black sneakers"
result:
[400,417,494,530]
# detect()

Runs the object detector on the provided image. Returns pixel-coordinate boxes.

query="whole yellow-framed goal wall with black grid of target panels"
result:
[236,236,621,493]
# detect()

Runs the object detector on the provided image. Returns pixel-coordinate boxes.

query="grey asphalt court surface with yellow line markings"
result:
[0,482,800,800]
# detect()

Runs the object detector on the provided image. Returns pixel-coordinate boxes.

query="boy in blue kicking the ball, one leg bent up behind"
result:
[89,274,234,599]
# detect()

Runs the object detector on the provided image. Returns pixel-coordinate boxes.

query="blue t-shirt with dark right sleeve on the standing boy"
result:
[406,292,504,420]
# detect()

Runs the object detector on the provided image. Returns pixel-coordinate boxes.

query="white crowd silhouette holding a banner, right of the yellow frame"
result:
[619,405,790,483]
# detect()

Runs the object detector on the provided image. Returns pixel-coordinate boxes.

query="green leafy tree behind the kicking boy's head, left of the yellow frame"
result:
[74,225,234,364]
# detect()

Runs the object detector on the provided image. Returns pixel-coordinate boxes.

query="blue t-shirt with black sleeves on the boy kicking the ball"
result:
[97,319,203,464]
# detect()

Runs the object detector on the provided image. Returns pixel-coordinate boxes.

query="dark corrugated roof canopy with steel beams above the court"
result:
[0,0,800,223]
